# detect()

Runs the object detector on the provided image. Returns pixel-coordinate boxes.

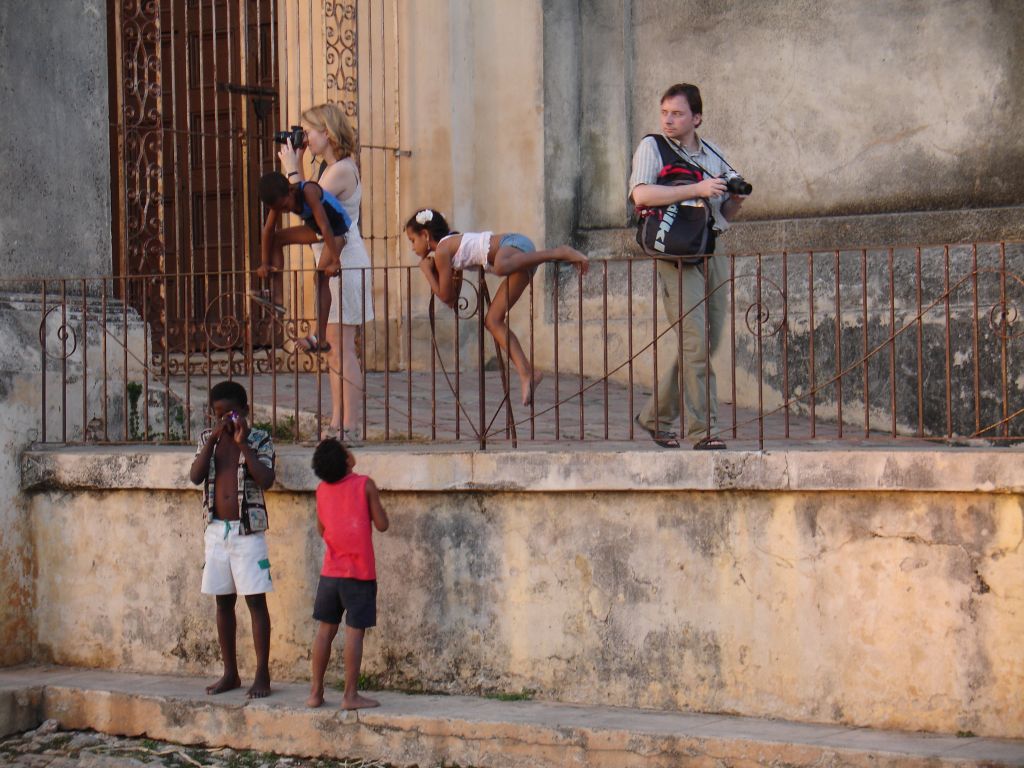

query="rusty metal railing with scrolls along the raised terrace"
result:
[18,237,1024,449]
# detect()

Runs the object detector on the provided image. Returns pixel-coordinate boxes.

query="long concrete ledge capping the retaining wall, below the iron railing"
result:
[22,444,1024,494]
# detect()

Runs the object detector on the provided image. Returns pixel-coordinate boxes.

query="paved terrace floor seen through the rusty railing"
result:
[159,370,937,451]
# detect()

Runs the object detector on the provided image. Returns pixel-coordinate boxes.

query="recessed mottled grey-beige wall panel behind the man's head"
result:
[632,0,1024,218]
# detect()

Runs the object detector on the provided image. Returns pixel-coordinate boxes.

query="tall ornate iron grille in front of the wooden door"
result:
[110,0,397,368]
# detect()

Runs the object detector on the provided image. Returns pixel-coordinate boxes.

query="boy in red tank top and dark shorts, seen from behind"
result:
[306,439,388,710]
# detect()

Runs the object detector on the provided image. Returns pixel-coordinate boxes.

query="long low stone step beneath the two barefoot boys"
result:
[0,667,1024,768]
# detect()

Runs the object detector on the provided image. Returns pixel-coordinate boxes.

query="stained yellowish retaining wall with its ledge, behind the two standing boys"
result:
[16,450,1024,737]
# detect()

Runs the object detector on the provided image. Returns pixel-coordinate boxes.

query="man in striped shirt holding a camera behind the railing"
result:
[630,83,750,450]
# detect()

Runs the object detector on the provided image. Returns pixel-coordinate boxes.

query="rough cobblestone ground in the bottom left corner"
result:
[0,720,395,768]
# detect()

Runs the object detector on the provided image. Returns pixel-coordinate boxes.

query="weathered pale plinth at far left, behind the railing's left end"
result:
[0,294,144,667]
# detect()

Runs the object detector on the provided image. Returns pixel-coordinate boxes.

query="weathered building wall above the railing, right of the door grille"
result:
[399,0,1024,248]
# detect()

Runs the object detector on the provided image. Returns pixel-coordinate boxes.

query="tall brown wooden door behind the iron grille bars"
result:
[160,0,278,352]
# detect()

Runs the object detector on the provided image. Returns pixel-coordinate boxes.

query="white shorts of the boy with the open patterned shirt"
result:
[202,520,273,595]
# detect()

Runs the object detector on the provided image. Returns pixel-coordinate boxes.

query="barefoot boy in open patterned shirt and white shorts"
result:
[188,381,274,698]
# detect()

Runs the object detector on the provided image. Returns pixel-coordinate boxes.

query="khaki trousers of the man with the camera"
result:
[639,256,729,440]
